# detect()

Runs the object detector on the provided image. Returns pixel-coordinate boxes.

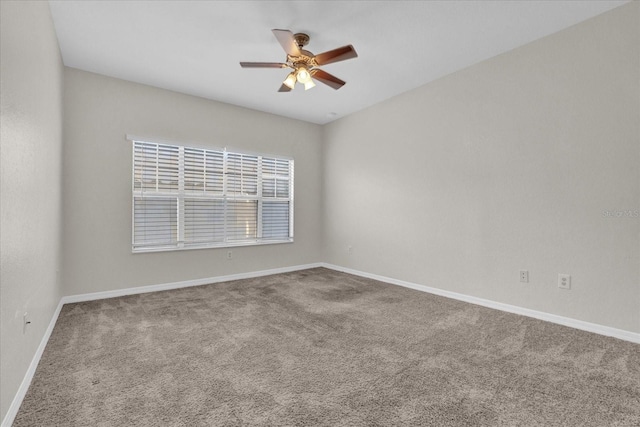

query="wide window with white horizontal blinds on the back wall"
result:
[132,140,293,252]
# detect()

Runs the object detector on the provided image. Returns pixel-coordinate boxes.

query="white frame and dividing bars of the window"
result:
[126,135,295,253]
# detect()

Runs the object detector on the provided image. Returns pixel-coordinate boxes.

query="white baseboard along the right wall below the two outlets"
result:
[321,263,640,344]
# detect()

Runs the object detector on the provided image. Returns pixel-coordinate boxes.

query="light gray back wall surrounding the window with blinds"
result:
[63,68,322,295]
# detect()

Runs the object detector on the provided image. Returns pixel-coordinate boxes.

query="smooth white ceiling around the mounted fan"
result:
[49,0,627,124]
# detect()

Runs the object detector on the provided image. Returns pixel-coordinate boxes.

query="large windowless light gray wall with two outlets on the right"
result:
[323,2,640,332]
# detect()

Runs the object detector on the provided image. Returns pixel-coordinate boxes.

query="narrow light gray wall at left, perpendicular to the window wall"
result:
[0,1,63,419]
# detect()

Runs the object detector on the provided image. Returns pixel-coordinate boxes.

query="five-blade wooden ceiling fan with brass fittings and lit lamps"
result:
[240,30,358,92]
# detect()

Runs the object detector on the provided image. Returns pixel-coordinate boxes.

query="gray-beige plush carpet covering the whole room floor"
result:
[14,268,640,427]
